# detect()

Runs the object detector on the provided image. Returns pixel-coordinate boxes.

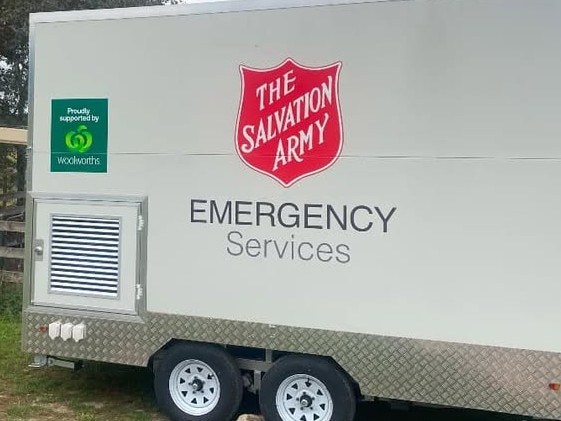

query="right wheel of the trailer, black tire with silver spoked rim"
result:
[259,355,356,421]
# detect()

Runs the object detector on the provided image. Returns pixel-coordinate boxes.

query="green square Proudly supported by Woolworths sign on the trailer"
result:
[51,98,107,172]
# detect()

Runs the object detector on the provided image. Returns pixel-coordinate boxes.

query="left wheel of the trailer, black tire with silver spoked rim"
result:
[154,343,243,421]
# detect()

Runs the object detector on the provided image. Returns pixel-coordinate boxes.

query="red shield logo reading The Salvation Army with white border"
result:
[236,58,343,187]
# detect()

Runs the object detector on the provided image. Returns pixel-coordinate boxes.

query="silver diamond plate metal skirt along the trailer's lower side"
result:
[23,310,561,419]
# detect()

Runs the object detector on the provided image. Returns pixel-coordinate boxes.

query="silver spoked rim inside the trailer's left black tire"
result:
[169,360,220,416]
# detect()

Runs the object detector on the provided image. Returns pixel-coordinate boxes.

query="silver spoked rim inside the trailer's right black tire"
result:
[276,374,333,421]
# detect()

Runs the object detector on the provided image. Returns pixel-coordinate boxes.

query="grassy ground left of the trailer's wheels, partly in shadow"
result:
[0,285,165,421]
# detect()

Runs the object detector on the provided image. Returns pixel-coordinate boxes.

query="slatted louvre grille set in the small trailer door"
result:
[50,215,121,297]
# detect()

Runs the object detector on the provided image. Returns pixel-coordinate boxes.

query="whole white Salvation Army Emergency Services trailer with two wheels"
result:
[23,0,561,421]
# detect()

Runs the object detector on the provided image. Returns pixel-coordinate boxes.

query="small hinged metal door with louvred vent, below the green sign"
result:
[31,198,142,314]
